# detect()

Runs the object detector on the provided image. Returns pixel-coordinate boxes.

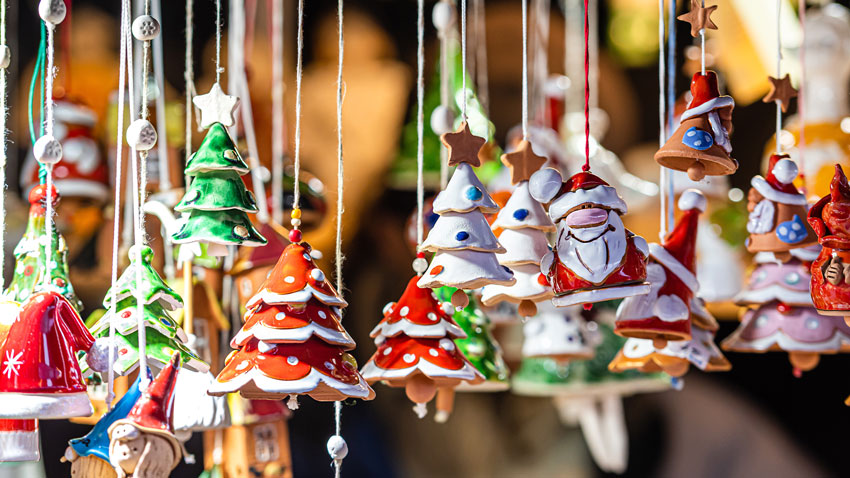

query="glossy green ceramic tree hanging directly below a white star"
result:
[171,123,266,257]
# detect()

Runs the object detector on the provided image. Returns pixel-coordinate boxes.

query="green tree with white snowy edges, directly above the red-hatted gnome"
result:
[80,246,209,375]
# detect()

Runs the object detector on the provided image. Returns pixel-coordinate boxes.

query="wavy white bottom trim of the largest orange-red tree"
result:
[207,367,372,398]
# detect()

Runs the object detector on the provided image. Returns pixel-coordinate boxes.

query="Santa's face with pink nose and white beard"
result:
[557,203,626,284]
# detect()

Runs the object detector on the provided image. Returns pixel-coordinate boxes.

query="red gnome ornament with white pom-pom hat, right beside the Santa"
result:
[614,189,706,348]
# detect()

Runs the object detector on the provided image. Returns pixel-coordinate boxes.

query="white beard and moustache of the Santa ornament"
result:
[558,211,627,284]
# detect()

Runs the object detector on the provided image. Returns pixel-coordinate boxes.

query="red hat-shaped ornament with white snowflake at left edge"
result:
[0,290,106,418]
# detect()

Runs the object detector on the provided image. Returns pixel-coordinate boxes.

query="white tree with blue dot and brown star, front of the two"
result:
[418,123,516,308]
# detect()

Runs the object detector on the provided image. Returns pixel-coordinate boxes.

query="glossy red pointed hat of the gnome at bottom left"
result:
[109,352,182,469]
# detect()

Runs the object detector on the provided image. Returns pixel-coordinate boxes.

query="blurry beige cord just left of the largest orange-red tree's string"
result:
[271,0,286,224]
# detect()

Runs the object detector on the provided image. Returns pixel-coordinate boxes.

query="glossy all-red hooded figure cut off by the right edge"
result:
[809,164,850,324]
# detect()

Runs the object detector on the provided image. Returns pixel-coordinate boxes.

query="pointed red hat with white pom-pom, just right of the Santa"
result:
[649,189,706,292]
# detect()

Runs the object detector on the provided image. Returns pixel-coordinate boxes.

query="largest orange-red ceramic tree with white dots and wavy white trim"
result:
[209,243,375,407]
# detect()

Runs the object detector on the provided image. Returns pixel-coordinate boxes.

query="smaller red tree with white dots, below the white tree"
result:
[362,277,484,421]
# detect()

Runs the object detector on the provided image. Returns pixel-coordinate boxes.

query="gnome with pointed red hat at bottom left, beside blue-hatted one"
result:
[107,353,183,478]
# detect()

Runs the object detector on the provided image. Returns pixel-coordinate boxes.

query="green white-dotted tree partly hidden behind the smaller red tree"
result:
[434,287,510,391]
